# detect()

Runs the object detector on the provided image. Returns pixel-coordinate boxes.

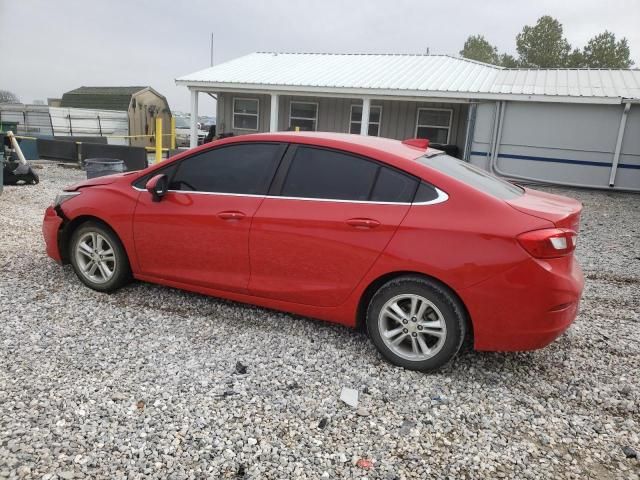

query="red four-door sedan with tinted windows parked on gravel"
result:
[43,132,583,370]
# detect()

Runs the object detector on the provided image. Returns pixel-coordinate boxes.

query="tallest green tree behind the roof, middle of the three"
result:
[516,15,571,68]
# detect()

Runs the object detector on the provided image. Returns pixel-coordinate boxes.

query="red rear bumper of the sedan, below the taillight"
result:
[460,255,584,351]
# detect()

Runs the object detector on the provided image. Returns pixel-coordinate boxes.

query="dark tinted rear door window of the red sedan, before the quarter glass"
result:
[282,147,379,200]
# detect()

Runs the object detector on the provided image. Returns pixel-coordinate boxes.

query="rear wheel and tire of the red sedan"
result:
[366,276,467,372]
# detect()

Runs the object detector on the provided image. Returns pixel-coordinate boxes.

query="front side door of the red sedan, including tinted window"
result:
[133,143,286,293]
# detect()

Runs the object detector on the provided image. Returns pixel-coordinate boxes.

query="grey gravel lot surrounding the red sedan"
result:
[0,165,640,479]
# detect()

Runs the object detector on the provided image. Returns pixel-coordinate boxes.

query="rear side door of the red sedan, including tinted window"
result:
[249,145,418,306]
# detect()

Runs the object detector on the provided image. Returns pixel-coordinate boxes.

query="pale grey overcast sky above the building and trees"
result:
[0,0,640,114]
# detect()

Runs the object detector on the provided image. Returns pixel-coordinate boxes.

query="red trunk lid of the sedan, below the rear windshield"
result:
[507,188,582,231]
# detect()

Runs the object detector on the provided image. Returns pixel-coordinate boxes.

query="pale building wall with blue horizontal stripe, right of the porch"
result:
[469,102,640,190]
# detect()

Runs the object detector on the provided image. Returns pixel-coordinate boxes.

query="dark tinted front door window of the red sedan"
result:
[169,143,282,195]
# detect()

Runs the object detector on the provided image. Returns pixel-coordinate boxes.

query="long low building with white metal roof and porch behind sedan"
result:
[176,53,640,191]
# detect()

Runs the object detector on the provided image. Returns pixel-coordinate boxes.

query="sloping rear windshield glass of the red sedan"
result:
[417,153,524,200]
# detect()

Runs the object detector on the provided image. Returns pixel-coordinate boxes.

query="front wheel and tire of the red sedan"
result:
[69,221,131,293]
